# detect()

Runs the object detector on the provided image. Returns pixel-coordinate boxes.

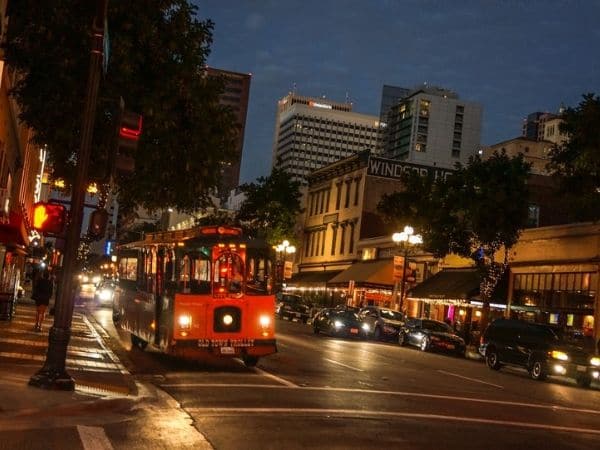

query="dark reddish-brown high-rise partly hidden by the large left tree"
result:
[207,67,251,200]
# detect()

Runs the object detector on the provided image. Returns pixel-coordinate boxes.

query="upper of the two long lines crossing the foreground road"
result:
[160,383,600,415]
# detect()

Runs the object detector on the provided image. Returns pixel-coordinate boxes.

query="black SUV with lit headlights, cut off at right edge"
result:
[479,319,600,387]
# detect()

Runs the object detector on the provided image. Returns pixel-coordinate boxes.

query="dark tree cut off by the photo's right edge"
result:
[549,94,600,222]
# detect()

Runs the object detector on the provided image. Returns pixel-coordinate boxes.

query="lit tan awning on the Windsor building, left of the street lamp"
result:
[327,259,394,289]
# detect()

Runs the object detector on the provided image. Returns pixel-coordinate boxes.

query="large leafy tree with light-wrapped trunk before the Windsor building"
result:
[378,152,530,324]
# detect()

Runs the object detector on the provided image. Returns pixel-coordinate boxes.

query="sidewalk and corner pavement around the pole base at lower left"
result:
[0,299,212,450]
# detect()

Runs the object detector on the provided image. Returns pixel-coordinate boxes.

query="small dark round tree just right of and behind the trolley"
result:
[237,168,302,245]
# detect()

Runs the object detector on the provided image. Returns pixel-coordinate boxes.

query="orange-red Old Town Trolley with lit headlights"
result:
[113,226,277,366]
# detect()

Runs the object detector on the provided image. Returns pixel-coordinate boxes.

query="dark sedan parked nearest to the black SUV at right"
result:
[398,319,466,356]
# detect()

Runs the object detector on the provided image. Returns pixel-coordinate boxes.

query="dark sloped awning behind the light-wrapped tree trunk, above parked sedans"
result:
[407,268,481,301]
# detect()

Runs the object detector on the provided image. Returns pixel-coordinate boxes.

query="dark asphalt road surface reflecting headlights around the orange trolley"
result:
[93,310,600,450]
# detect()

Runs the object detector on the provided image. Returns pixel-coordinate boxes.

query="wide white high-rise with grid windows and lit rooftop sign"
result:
[272,93,380,183]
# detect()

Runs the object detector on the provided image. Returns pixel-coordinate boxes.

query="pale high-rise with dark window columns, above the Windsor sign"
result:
[383,86,482,168]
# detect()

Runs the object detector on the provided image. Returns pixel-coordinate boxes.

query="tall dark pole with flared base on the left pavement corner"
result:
[29,0,108,390]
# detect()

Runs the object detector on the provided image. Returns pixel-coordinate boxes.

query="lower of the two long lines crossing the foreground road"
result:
[186,408,600,435]
